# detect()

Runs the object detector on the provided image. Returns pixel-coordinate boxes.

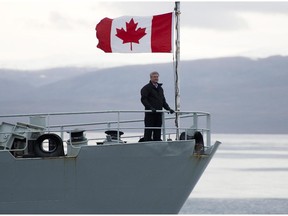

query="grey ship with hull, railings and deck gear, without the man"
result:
[0,110,220,214]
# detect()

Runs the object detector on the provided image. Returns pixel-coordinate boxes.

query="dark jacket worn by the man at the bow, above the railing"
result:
[141,81,170,110]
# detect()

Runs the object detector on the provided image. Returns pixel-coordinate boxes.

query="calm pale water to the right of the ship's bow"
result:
[180,134,288,214]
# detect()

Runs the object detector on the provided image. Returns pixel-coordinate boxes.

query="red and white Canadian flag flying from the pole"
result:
[95,13,173,53]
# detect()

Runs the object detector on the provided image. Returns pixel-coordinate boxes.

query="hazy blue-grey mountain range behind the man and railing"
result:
[0,56,288,133]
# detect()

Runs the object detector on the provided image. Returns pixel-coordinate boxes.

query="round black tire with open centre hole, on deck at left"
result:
[34,133,64,157]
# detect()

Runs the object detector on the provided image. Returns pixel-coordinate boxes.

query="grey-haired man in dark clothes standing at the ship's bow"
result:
[141,71,174,141]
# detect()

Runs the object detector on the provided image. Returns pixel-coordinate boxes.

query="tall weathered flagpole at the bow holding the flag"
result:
[174,1,181,140]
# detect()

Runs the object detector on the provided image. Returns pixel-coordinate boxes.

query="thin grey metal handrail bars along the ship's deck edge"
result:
[0,110,211,152]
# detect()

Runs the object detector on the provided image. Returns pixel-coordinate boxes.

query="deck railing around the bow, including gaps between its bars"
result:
[0,110,211,153]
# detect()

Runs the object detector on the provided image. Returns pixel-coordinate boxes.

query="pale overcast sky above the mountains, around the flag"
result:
[0,0,288,69]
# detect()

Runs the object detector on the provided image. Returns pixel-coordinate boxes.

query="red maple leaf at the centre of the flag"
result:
[116,18,146,51]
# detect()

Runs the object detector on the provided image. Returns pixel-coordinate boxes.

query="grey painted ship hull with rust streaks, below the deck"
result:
[0,140,220,214]
